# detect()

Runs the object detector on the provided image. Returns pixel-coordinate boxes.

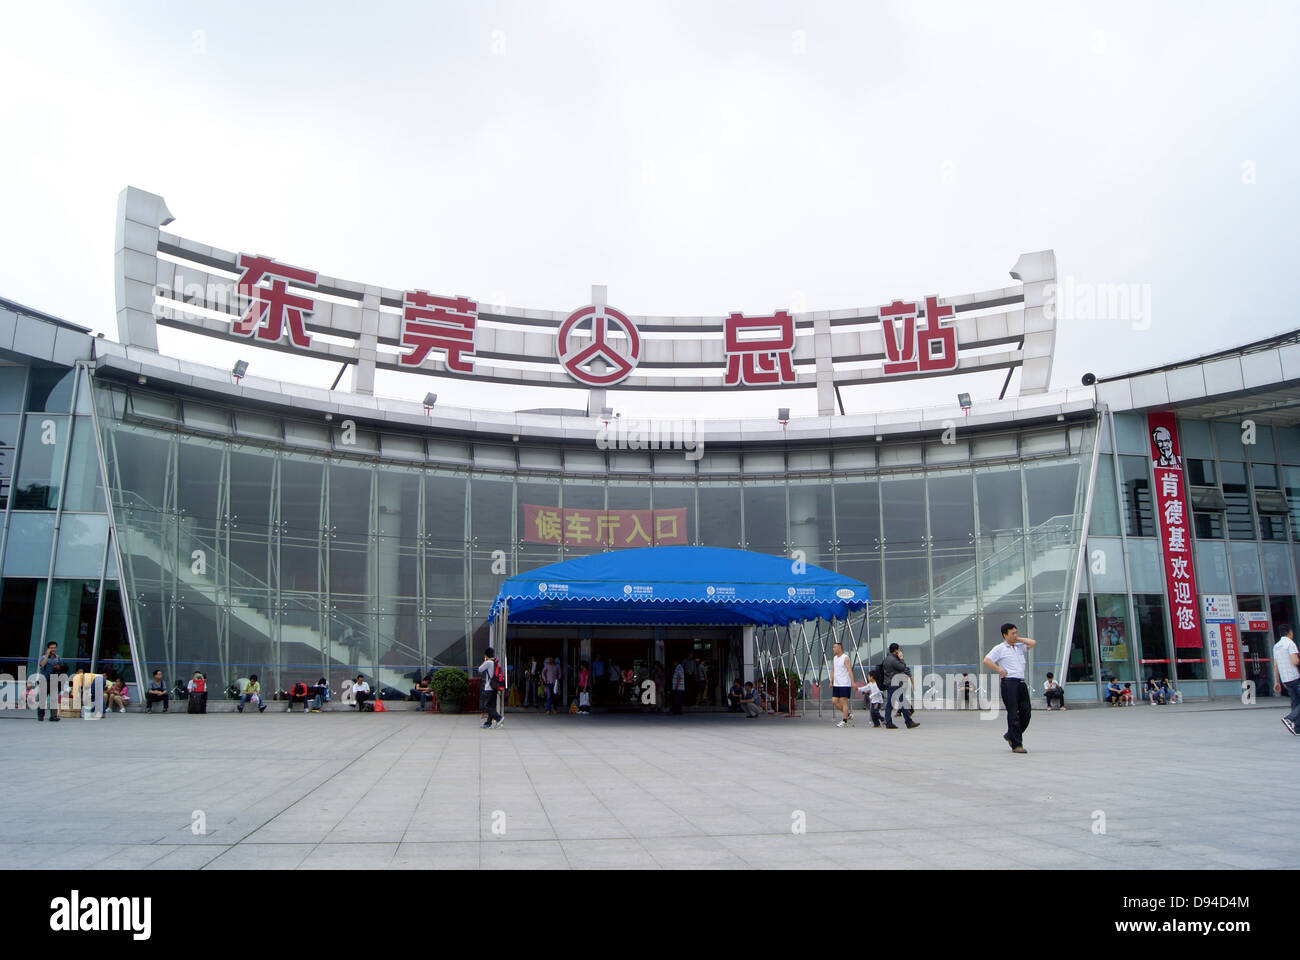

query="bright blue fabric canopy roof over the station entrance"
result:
[489,546,871,626]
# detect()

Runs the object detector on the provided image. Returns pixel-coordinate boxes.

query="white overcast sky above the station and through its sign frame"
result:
[0,0,1300,415]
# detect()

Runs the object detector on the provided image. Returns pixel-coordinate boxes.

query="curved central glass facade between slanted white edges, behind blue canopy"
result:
[86,384,1095,688]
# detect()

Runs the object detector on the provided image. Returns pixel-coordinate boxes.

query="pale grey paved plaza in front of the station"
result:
[0,700,1300,869]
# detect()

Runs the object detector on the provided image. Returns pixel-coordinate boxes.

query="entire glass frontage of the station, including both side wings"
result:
[0,340,1300,699]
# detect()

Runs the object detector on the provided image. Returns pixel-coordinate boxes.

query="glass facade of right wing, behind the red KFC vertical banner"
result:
[1069,414,1300,696]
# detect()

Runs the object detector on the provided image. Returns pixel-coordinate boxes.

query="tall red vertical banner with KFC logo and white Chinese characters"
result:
[1147,411,1201,649]
